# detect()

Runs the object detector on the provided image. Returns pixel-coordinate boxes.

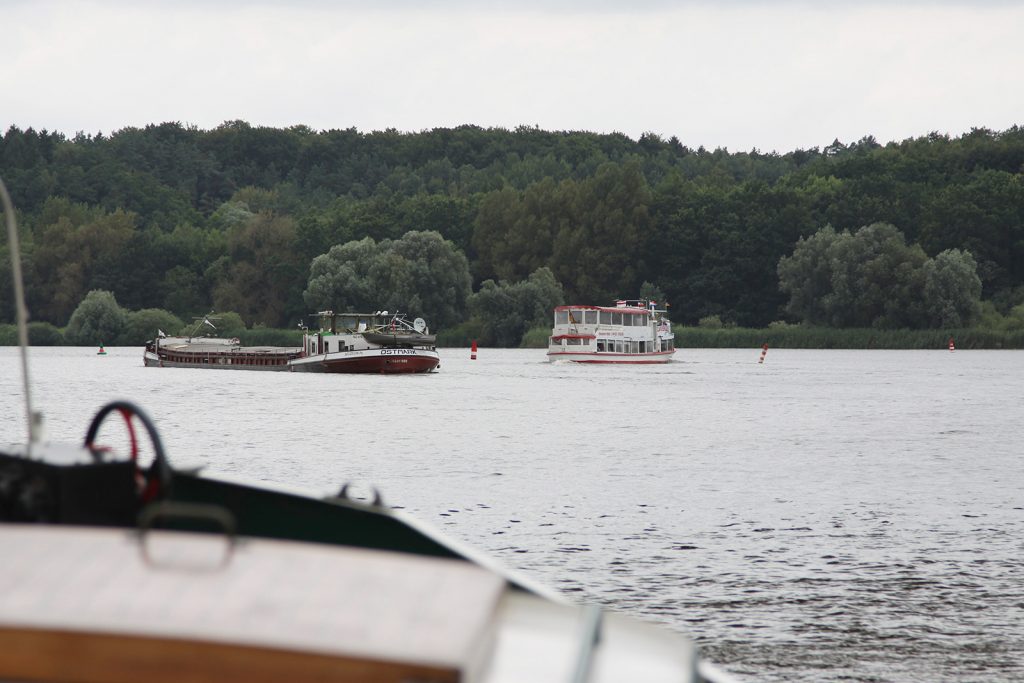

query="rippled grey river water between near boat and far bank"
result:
[0,347,1024,682]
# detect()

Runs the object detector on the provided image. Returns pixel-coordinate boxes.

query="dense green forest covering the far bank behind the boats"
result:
[0,121,1024,344]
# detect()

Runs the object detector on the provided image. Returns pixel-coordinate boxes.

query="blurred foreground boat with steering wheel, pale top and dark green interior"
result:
[0,401,728,683]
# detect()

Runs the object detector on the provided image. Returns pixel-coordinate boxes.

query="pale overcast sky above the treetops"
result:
[0,0,1024,153]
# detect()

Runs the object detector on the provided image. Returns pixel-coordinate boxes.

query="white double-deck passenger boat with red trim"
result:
[548,299,676,364]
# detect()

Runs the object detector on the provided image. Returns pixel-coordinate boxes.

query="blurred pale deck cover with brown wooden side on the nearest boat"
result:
[0,524,698,683]
